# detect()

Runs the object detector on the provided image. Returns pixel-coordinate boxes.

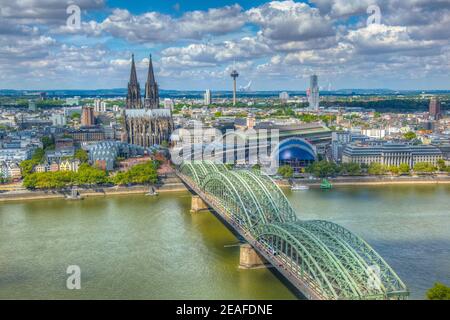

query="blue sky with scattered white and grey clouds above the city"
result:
[0,0,450,90]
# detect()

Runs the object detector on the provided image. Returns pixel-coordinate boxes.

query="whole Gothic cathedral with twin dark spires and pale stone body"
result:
[124,55,173,148]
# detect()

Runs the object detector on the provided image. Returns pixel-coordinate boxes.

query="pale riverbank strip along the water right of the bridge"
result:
[277,176,450,187]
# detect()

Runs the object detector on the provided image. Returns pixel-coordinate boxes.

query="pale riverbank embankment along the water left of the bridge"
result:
[0,175,187,203]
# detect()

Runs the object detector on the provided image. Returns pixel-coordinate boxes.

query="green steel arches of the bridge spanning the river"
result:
[179,161,409,299]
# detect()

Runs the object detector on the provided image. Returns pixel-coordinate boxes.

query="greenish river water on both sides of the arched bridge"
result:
[0,186,450,299]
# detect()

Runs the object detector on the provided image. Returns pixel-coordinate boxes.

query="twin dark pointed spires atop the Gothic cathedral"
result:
[126,54,159,109]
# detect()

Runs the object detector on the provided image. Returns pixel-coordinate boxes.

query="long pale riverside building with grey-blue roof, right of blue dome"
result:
[342,142,443,168]
